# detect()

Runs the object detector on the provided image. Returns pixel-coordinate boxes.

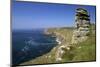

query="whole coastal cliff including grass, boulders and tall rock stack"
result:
[20,8,96,65]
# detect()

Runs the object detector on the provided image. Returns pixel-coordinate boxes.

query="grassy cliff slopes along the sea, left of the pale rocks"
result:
[21,28,73,65]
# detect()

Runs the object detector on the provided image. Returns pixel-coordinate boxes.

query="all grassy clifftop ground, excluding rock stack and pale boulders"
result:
[21,25,96,65]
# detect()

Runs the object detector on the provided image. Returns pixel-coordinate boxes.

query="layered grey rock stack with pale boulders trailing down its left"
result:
[55,8,90,61]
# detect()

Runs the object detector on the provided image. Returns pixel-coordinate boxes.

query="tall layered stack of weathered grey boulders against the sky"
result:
[72,8,90,44]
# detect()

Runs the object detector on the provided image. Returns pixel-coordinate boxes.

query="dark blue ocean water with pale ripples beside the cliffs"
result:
[12,29,57,65]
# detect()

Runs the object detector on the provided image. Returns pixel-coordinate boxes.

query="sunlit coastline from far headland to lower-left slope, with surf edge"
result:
[20,28,73,65]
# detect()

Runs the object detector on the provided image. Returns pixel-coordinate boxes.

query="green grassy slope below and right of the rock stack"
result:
[63,24,96,62]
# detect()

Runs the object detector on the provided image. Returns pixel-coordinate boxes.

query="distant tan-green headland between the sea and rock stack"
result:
[48,27,74,43]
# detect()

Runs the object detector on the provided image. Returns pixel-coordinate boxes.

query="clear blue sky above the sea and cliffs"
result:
[12,1,95,29]
